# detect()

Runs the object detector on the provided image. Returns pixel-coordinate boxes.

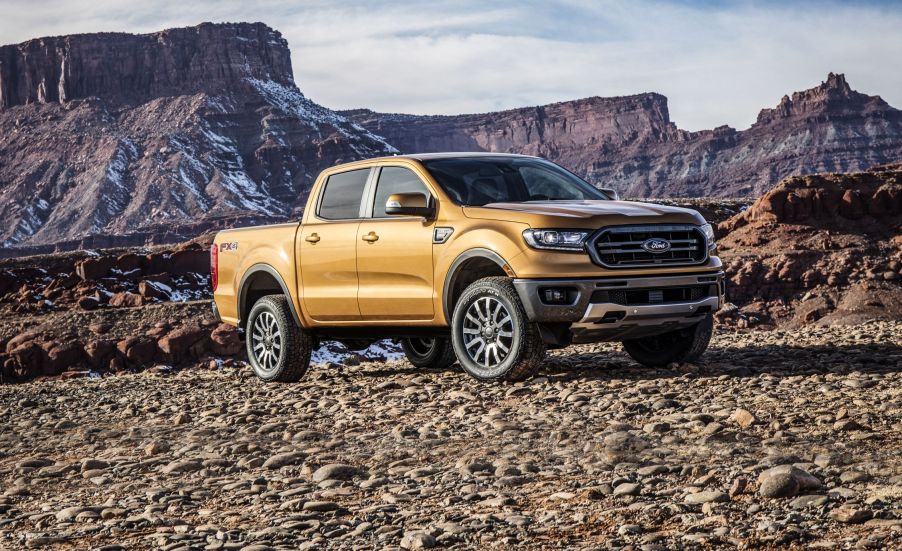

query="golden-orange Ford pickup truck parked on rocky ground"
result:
[211,153,724,381]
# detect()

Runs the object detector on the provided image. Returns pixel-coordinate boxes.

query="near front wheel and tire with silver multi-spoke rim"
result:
[451,277,545,381]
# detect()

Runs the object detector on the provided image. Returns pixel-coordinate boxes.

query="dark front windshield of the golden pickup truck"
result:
[422,157,609,206]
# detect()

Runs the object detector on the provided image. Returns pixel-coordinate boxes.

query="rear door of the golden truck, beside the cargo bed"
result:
[298,168,372,321]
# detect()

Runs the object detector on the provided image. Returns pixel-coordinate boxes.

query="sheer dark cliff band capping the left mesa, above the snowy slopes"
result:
[0,23,292,109]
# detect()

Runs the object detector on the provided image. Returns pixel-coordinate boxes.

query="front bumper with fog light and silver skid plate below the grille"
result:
[514,271,724,342]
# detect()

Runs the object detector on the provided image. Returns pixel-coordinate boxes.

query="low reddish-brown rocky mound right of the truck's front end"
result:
[717,167,902,325]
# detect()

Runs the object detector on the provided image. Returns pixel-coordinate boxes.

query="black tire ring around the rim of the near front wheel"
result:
[451,282,526,380]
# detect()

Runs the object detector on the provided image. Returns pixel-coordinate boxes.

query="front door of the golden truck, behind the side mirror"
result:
[357,166,435,320]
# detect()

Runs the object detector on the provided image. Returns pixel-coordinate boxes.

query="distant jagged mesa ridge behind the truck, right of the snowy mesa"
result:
[343,73,902,197]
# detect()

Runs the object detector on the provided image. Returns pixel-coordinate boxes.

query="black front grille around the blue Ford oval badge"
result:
[591,225,708,268]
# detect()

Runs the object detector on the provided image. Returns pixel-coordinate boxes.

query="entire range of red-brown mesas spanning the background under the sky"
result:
[0,19,902,257]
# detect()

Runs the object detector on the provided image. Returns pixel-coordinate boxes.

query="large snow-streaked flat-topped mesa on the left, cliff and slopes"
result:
[0,23,395,254]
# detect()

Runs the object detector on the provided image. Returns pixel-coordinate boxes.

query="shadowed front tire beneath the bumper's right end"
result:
[623,314,714,367]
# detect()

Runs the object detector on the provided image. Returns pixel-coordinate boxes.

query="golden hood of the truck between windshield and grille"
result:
[464,201,705,229]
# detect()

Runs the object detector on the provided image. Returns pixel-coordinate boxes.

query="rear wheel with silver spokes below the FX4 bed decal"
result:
[245,295,316,383]
